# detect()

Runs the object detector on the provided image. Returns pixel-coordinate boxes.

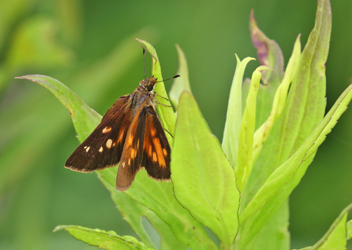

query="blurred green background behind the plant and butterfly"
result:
[0,0,352,249]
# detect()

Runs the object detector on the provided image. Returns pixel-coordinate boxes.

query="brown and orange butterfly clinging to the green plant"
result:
[65,50,179,191]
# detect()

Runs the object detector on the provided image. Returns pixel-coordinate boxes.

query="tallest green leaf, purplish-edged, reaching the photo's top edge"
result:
[276,0,331,164]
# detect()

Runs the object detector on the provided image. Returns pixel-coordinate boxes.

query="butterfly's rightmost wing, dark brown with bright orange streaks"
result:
[142,106,171,180]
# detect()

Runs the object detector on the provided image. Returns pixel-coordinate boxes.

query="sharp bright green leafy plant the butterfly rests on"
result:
[9,0,352,250]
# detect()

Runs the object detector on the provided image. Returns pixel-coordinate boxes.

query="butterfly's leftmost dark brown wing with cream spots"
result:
[65,95,132,172]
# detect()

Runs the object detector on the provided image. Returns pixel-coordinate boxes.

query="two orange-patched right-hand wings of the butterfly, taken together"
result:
[116,106,171,191]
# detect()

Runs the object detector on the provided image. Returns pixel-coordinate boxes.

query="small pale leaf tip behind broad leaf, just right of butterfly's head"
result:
[170,44,191,107]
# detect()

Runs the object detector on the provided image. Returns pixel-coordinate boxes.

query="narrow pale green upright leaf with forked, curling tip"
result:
[222,55,254,169]
